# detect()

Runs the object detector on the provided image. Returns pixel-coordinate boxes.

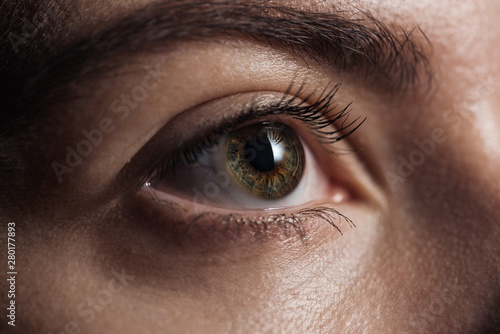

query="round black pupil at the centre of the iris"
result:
[245,136,279,172]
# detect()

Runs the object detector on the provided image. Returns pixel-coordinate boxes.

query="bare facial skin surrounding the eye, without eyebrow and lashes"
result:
[0,0,500,333]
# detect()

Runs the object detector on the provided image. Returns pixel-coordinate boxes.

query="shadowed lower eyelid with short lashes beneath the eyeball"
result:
[123,188,355,251]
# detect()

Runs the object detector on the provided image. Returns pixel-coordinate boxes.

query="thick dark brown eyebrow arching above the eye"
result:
[0,0,432,129]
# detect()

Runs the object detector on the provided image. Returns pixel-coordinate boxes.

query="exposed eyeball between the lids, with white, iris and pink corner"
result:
[147,121,348,209]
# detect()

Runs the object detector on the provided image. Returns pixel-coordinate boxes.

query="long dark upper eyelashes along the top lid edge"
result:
[143,82,366,186]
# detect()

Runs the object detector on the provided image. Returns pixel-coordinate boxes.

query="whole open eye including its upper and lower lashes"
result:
[126,86,362,239]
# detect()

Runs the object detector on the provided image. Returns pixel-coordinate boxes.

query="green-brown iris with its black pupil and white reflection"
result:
[225,122,305,198]
